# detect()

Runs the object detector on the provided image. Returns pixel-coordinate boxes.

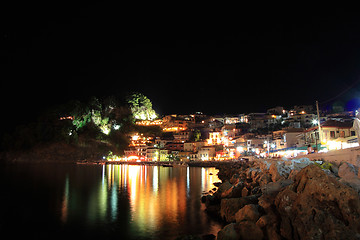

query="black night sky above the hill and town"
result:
[1,3,360,120]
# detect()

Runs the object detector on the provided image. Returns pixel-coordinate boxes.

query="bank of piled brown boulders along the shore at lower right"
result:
[202,158,360,240]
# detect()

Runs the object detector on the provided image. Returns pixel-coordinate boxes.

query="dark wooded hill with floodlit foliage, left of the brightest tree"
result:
[1,97,134,152]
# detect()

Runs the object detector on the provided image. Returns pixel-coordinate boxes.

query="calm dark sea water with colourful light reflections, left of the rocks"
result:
[0,164,221,239]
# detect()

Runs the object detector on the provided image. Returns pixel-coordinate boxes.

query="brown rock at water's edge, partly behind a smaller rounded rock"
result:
[220,195,258,222]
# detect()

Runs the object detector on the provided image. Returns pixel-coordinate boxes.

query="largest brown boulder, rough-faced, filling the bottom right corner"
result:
[275,165,360,239]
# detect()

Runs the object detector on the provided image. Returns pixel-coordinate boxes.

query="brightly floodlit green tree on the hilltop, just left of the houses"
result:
[128,93,157,120]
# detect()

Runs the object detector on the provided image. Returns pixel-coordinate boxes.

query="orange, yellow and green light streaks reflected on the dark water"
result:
[61,165,219,236]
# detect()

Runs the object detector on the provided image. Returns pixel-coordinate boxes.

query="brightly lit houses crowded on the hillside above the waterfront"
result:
[125,105,358,161]
